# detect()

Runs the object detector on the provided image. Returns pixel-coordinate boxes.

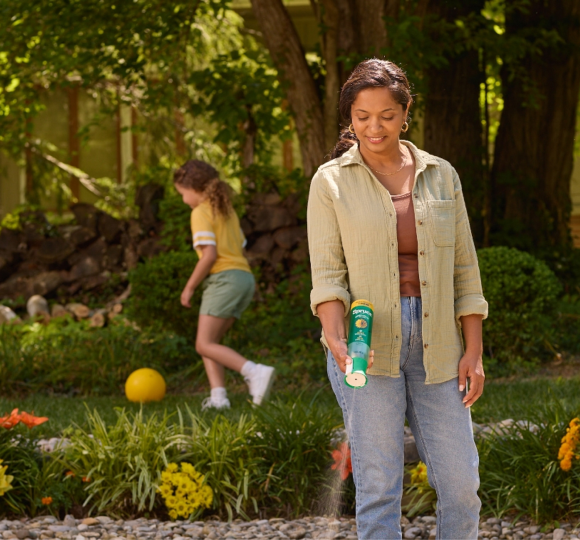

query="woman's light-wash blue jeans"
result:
[328,297,481,540]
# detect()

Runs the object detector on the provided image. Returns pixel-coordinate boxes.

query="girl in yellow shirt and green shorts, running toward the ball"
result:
[173,159,274,409]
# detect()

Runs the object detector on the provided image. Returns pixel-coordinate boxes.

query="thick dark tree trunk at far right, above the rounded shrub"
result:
[491,0,580,251]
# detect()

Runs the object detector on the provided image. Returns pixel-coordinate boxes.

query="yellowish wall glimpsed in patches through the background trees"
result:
[0,0,580,247]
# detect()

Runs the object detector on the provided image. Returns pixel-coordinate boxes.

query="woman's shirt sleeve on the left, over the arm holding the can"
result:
[307,170,350,316]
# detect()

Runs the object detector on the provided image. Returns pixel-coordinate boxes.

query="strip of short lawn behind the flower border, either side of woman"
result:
[0,377,580,437]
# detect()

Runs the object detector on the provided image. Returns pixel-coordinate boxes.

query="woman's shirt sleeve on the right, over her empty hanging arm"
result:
[453,169,488,325]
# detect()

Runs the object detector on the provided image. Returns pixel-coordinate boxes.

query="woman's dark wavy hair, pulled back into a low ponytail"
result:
[330,58,413,159]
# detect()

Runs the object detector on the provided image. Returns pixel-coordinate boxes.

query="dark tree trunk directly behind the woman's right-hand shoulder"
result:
[424,0,487,244]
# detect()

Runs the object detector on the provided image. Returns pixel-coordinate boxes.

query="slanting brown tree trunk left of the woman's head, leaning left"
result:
[251,0,330,176]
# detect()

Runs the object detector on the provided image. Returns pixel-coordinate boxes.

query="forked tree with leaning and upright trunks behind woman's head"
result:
[251,0,404,176]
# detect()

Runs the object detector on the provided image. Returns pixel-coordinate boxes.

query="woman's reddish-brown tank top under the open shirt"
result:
[391,192,421,297]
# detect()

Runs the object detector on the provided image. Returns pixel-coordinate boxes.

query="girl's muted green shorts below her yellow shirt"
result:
[199,270,256,319]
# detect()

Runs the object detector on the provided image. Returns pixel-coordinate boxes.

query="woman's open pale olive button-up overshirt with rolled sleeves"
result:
[308,141,487,384]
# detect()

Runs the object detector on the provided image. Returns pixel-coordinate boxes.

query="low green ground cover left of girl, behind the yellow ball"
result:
[0,318,199,396]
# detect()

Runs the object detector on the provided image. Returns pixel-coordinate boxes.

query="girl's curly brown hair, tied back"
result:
[173,159,232,217]
